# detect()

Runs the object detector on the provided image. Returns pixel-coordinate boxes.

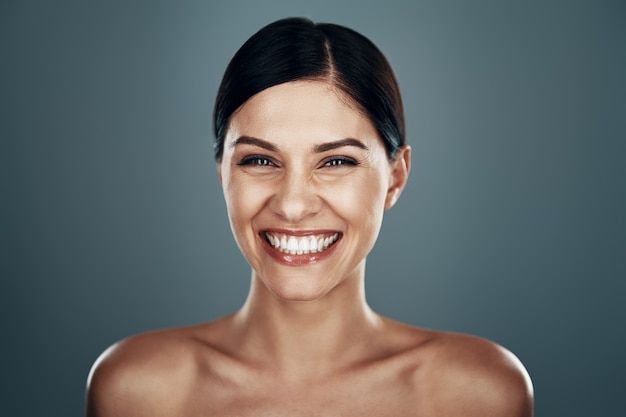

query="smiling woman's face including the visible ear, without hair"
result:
[219,81,409,301]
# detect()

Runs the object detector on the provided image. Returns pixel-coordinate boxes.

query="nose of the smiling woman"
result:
[270,170,322,224]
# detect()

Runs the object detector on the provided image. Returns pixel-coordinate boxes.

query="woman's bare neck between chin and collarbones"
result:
[234,266,381,378]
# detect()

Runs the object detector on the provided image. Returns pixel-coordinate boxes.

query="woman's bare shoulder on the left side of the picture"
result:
[87,327,217,417]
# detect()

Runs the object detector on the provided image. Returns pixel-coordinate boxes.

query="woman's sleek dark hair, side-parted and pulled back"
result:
[213,18,405,162]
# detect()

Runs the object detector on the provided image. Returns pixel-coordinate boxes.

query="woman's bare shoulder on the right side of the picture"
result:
[418,332,533,417]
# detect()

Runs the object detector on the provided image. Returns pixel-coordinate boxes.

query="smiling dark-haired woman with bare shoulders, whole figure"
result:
[87,19,532,417]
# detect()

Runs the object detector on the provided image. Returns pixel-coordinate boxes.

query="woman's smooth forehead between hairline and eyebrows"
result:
[226,81,382,144]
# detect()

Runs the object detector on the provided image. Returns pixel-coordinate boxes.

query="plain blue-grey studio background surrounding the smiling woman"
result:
[0,0,626,417]
